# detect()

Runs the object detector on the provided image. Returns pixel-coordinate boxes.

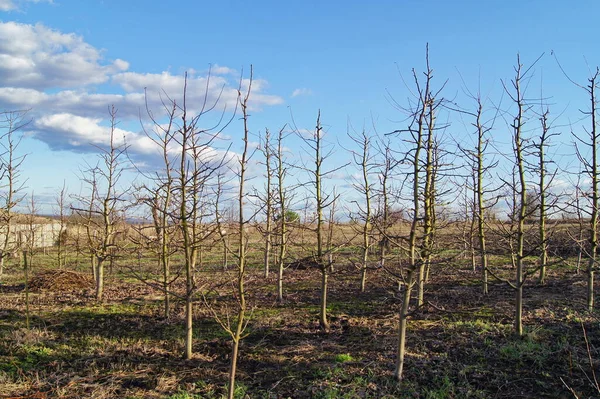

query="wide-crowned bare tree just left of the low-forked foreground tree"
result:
[142,73,237,359]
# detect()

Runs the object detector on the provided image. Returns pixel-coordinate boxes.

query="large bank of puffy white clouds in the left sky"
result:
[0,21,283,162]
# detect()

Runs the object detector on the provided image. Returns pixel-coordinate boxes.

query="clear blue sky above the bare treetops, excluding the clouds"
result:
[0,0,600,216]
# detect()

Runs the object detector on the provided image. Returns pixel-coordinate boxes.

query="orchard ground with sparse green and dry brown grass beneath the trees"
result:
[0,223,600,399]
